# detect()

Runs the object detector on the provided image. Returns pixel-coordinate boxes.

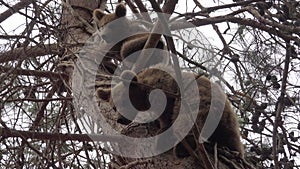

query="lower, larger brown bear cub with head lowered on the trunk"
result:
[96,65,244,157]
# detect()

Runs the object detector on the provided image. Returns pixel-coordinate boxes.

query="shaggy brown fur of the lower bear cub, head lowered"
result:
[97,65,244,157]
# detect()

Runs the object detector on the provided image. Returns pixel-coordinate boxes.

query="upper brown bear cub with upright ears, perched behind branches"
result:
[93,3,168,69]
